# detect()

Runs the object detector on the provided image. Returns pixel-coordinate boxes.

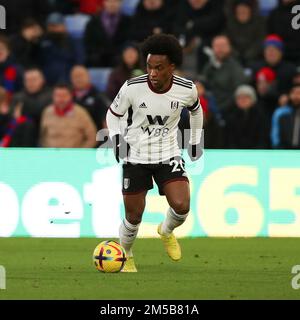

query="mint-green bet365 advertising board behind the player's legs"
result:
[0,149,300,238]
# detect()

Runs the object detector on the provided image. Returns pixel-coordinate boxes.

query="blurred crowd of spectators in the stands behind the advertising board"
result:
[0,0,300,149]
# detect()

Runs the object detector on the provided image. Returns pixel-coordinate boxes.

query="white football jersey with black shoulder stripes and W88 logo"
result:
[110,74,200,164]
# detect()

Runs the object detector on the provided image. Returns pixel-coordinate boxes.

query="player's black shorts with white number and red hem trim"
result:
[122,157,189,195]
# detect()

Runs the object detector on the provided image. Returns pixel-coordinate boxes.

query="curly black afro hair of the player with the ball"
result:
[141,33,183,67]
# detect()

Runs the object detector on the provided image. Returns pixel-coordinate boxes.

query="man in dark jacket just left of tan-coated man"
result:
[12,67,52,145]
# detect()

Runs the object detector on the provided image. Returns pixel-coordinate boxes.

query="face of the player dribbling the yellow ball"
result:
[147,54,175,91]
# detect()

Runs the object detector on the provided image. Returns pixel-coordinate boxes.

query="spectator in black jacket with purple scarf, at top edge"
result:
[84,0,131,67]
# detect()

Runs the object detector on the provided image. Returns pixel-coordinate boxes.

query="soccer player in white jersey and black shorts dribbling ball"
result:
[107,34,203,272]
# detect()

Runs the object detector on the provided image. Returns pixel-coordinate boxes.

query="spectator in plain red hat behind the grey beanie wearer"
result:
[256,67,279,123]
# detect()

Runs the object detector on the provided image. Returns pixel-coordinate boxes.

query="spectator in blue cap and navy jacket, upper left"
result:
[40,13,76,85]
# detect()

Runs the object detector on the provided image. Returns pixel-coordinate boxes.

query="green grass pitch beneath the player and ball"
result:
[0,238,300,300]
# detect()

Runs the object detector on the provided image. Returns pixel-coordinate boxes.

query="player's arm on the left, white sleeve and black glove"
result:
[106,82,131,162]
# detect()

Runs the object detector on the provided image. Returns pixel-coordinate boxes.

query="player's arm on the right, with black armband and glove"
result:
[187,86,203,161]
